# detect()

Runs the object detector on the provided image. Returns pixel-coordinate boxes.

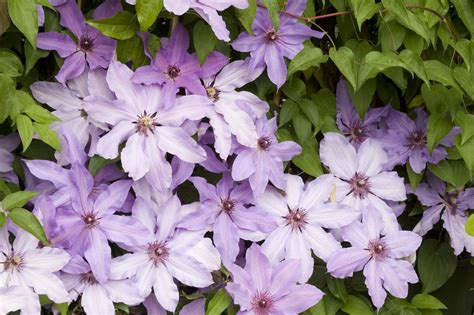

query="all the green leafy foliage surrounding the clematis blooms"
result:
[0,0,474,315]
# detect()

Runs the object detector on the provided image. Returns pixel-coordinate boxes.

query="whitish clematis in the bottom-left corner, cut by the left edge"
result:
[0,227,70,314]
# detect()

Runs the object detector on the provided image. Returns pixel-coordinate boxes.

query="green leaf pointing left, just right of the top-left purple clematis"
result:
[87,11,139,39]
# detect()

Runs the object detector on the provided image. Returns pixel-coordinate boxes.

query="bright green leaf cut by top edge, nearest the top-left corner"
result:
[8,0,38,47]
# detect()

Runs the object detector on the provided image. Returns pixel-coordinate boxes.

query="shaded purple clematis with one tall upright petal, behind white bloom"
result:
[336,79,391,148]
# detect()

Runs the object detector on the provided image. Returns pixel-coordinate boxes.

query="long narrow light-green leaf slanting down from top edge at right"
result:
[382,0,430,41]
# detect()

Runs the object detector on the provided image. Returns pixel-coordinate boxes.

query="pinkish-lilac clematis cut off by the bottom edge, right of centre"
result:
[226,243,324,315]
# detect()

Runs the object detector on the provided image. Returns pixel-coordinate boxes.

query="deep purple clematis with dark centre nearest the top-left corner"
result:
[37,0,115,84]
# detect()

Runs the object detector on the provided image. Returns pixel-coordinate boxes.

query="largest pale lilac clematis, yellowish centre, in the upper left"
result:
[86,61,209,191]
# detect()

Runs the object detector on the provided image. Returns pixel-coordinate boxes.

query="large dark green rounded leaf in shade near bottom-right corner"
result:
[417,239,458,293]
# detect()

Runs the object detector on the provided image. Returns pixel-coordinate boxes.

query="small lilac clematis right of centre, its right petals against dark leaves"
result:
[232,116,301,196]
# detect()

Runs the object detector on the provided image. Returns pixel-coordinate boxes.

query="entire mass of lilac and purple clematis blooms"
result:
[0,0,474,315]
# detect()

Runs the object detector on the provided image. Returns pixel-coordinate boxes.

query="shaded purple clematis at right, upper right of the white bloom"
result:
[383,108,459,173]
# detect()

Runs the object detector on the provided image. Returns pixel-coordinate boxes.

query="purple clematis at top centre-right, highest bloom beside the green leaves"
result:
[232,0,324,88]
